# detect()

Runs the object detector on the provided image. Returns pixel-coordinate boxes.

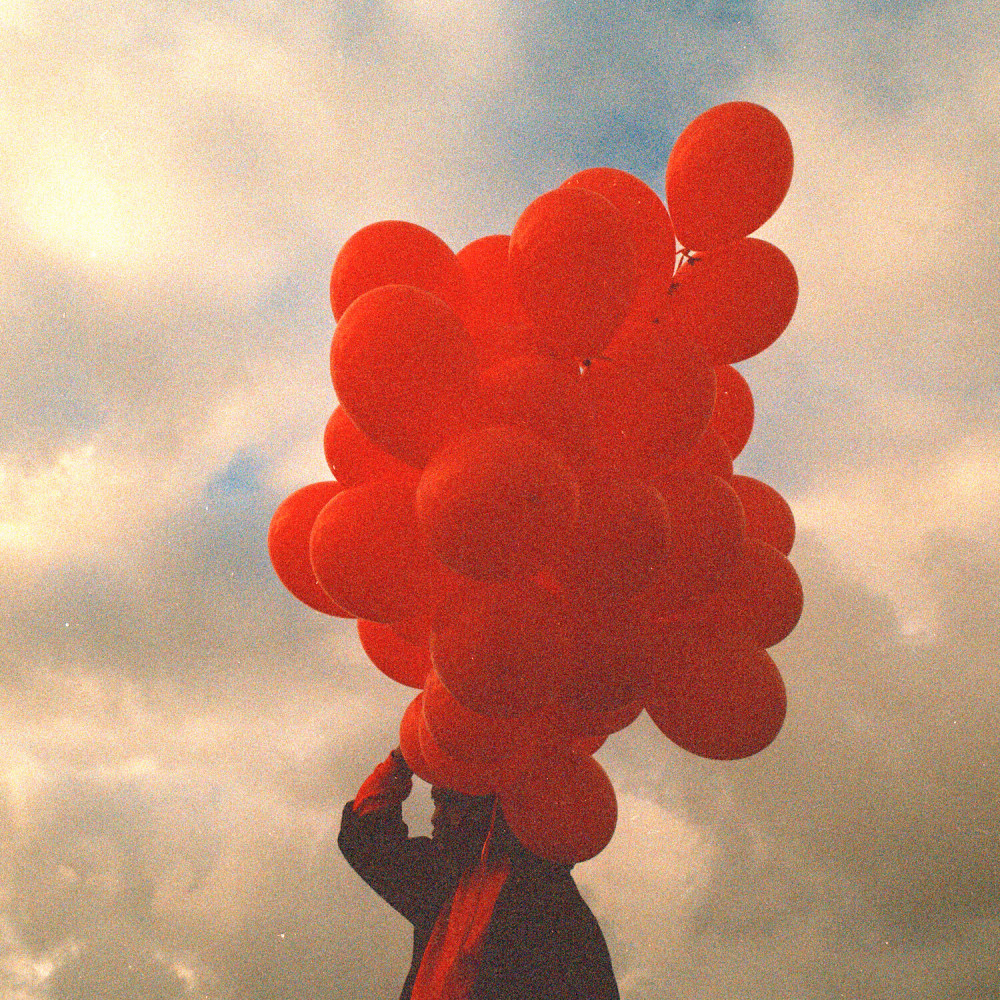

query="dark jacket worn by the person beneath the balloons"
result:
[338,802,618,1000]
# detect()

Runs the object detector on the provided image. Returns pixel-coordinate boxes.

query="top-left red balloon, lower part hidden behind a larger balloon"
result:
[330,219,465,320]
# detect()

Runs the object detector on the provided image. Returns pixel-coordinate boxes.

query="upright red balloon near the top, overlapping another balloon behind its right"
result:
[510,187,637,358]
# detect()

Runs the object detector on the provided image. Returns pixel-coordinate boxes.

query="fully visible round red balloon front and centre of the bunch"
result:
[415,427,578,579]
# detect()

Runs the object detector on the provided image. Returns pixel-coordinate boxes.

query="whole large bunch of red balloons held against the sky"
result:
[268,102,802,862]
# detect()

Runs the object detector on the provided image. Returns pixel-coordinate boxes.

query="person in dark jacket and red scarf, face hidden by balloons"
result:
[338,747,619,1000]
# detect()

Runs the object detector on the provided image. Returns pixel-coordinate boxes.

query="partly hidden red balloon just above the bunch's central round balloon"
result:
[480,354,594,467]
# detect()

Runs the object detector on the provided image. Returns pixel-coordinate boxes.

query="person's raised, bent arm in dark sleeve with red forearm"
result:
[337,748,448,926]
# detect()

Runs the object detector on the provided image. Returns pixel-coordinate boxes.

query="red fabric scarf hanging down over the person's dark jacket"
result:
[411,851,510,1000]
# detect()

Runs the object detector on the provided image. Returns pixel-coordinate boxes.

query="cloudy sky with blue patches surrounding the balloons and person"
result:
[0,0,1000,1000]
